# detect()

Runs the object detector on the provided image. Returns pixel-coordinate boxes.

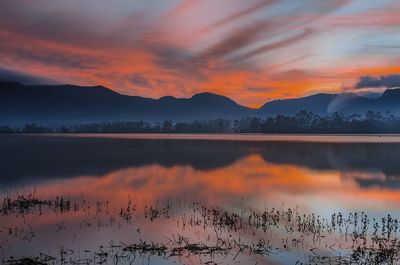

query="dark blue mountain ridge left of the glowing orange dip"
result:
[0,82,250,125]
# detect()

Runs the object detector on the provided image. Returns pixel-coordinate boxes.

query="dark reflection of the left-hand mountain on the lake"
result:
[0,135,250,182]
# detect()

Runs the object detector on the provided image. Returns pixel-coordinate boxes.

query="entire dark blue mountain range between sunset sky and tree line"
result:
[0,82,400,125]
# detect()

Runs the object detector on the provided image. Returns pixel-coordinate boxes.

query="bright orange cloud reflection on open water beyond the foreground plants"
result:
[12,154,400,213]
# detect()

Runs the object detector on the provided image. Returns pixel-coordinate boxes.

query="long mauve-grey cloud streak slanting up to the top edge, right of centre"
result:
[191,0,350,67]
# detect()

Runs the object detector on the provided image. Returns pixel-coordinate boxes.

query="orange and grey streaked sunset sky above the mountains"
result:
[0,0,400,107]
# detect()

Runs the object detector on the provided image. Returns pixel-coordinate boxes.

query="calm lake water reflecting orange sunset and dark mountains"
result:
[0,135,400,264]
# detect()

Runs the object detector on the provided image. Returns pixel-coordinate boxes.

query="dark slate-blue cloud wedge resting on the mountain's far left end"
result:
[0,68,57,85]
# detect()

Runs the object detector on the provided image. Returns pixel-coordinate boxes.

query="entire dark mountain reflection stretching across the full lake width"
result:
[0,135,400,188]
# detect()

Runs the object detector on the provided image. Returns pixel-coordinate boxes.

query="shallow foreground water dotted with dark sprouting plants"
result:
[0,193,400,265]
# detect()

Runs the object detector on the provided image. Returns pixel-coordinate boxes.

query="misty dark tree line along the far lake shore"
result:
[0,111,400,134]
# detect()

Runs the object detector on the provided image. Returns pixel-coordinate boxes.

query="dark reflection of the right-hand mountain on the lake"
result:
[261,142,400,176]
